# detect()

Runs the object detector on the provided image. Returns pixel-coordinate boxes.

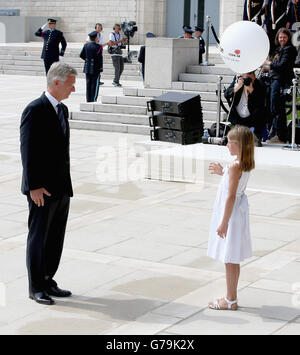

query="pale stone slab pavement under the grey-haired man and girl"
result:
[0,76,300,334]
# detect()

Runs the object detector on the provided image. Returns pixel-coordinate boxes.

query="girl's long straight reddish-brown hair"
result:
[228,126,255,172]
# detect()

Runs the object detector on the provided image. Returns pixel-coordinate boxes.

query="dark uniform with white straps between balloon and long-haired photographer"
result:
[265,0,289,54]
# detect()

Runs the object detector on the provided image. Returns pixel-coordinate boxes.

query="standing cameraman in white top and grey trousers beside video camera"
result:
[108,24,127,87]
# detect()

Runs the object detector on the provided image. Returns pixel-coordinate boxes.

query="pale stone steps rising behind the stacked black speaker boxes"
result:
[70,55,234,135]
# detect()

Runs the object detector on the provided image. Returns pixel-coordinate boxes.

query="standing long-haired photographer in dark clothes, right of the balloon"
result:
[265,28,297,144]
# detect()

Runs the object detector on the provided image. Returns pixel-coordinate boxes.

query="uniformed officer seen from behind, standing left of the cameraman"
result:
[80,31,103,102]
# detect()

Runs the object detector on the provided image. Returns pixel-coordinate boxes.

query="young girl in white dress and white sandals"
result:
[207,126,255,310]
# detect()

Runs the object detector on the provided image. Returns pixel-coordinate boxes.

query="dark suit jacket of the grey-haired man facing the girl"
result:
[20,94,73,198]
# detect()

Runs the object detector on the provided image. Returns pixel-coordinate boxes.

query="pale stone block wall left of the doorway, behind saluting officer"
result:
[0,0,167,43]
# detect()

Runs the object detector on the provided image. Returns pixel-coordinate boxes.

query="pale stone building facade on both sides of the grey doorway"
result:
[0,0,244,44]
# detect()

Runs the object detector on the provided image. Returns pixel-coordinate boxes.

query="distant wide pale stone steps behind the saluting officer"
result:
[0,45,142,81]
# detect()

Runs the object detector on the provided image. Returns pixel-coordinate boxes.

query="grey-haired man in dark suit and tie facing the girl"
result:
[20,62,77,305]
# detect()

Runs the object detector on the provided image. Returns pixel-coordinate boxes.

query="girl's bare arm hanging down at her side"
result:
[217,164,242,238]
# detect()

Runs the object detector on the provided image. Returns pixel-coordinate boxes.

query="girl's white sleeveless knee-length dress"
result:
[207,166,252,264]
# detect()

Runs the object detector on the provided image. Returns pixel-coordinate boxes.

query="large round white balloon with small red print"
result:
[220,21,270,74]
